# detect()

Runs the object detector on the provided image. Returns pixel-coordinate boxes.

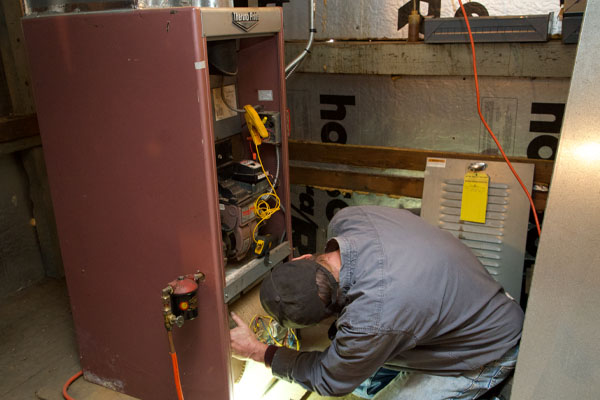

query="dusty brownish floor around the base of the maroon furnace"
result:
[0,279,358,400]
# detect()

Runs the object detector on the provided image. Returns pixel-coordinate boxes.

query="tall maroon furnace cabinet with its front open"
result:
[23,7,291,400]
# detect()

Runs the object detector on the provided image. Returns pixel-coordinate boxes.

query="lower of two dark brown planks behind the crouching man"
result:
[290,166,548,212]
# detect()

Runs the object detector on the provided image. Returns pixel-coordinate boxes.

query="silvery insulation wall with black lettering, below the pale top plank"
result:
[287,70,570,252]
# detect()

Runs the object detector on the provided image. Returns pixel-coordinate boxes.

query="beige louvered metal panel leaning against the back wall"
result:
[421,158,534,301]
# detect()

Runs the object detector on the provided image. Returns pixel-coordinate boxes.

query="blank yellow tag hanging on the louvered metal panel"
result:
[460,172,490,224]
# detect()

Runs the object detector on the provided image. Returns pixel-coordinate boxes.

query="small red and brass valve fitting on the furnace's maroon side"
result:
[162,271,204,331]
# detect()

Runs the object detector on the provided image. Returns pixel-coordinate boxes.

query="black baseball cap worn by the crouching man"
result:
[260,259,338,328]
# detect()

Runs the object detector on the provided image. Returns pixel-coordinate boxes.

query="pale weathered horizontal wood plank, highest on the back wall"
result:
[285,40,577,78]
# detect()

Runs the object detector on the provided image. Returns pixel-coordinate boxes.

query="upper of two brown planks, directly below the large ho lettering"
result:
[289,140,554,185]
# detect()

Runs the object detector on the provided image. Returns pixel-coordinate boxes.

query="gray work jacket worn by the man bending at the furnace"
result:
[271,206,524,395]
